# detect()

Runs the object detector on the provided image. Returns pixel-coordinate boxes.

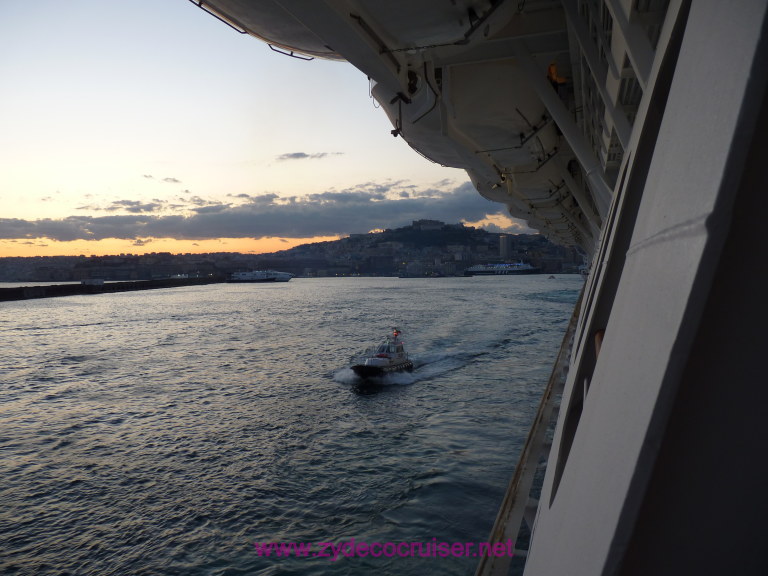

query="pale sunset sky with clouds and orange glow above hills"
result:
[0,0,531,256]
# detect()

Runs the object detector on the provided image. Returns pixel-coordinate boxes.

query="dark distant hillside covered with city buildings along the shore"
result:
[0,220,582,282]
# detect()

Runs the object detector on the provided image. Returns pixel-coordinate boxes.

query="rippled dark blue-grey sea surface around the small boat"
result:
[0,276,582,575]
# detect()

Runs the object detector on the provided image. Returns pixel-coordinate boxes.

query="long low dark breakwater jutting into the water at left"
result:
[0,276,225,302]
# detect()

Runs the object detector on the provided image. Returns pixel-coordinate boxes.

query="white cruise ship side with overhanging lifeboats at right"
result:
[188,0,768,576]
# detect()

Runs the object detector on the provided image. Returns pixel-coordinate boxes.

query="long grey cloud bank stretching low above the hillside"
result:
[0,181,536,241]
